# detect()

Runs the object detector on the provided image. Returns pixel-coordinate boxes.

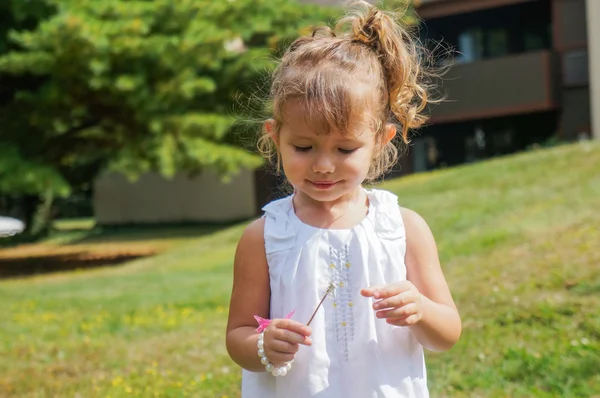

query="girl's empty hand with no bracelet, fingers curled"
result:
[360,281,425,326]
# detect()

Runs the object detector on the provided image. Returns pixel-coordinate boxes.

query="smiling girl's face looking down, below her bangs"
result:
[266,101,395,202]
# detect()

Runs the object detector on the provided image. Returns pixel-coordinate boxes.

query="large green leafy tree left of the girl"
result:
[0,0,338,235]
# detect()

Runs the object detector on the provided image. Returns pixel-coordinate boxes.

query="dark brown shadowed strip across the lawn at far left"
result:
[0,251,155,279]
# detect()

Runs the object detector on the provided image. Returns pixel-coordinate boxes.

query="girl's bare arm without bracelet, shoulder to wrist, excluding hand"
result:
[402,208,462,351]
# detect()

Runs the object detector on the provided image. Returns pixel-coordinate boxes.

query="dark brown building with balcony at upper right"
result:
[405,0,600,172]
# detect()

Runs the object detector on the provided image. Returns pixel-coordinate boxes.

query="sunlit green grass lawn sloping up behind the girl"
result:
[0,142,600,398]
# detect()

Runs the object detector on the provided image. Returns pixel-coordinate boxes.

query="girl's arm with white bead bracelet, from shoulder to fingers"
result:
[226,218,311,372]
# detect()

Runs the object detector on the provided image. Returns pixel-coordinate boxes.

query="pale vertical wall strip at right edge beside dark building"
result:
[587,0,600,139]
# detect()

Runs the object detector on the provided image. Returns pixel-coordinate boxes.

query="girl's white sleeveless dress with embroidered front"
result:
[242,190,429,398]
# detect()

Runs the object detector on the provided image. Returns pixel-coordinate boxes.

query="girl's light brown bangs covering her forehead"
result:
[277,67,381,135]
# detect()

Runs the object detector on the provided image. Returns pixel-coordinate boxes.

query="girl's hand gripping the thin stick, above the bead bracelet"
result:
[263,319,312,366]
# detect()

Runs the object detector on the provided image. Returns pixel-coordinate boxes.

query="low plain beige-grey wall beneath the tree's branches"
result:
[94,170,256,225]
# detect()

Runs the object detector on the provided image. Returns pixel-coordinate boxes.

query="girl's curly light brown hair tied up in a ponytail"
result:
[258,1,430,180]
